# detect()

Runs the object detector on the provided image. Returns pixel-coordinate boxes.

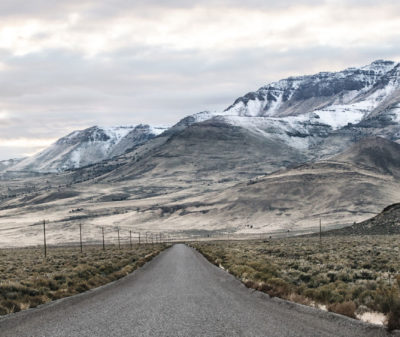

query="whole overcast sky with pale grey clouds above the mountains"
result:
[0,0,400,159]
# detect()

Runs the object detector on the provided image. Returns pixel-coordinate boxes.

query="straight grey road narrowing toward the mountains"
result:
[0,245,394,337]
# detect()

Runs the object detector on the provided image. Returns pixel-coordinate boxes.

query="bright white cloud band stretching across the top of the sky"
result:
[0,2,400,57]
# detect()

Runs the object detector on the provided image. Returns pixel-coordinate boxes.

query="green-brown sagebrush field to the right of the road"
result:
[193,236,400,329]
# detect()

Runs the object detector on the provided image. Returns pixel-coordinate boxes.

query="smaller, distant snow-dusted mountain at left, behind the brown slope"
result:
[9,124,166,172]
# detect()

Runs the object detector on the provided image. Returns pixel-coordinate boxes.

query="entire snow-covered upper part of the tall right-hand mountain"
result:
[177,60,400,157]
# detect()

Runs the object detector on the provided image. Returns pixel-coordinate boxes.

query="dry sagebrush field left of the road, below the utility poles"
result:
[0,245,166,315]
